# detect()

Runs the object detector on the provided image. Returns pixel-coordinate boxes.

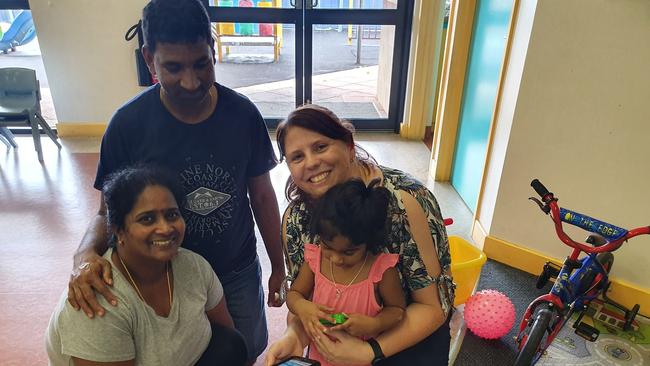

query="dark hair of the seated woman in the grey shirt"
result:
[102,165,185,232]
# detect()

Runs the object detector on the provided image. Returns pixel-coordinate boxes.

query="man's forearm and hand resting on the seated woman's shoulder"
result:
[68,196,117,318]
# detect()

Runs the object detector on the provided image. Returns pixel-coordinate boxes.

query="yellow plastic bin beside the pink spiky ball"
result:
[449,236,487,306]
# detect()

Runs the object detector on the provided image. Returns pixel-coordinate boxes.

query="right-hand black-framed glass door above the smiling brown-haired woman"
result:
[304,0,413,132]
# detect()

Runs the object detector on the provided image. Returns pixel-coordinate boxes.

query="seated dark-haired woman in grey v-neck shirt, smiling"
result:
[46,167,246,366]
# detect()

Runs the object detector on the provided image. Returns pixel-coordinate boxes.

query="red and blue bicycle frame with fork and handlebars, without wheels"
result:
[517,179,650,360]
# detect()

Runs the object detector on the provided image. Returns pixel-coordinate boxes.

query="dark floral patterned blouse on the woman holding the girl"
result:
[284,166,455,315]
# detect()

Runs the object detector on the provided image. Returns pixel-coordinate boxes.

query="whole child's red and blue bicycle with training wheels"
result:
[515,179,650,366]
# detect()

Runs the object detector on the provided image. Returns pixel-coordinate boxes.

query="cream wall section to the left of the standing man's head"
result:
[29,0,147,123]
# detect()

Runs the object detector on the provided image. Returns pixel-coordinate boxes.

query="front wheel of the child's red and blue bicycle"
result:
[515,304,553,366]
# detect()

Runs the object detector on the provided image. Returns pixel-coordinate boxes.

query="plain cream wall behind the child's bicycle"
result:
[480,0,650,288]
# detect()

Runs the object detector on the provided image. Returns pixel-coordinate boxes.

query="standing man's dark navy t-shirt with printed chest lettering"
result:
[94,83,277,274]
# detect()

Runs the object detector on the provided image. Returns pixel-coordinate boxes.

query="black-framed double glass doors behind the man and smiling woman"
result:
[204,0,413,132]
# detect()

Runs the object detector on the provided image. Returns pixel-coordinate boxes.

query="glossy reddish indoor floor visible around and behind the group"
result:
[0,133,472,365]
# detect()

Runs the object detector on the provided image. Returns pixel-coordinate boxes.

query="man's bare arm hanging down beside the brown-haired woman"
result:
[248,172,285,307]
